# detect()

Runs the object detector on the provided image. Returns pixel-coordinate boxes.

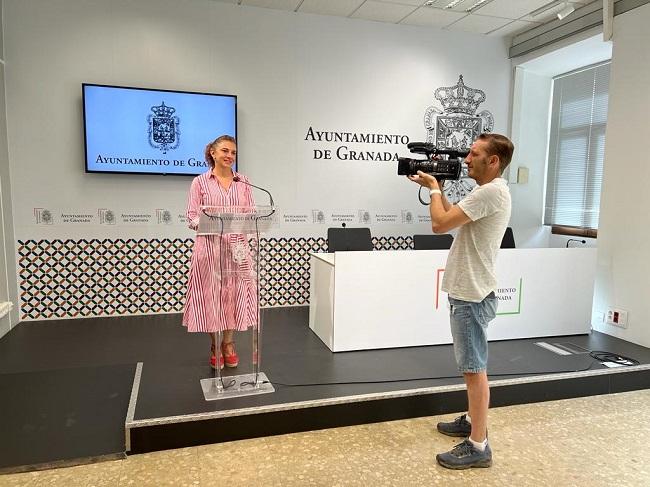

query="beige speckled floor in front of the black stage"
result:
[0,390,650,487]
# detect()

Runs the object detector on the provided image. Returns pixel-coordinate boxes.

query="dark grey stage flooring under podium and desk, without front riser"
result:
[0,307,650,472]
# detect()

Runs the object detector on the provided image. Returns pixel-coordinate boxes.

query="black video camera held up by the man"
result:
[397,142,469,181]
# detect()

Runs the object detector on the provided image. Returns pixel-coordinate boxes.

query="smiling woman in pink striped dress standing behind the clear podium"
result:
[183,135,258,369]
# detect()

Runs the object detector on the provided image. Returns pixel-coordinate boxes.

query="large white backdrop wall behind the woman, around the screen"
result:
[5,0,510,318]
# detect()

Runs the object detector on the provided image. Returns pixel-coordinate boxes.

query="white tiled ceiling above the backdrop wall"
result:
[215,0,602,37]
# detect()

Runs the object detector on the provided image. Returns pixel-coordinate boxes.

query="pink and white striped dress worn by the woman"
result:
[183,171,257,333]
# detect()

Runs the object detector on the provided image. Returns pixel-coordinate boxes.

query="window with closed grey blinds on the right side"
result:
[544,62,610,233]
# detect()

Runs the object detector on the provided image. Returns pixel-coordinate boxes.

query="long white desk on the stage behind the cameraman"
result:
[309,248,596,352]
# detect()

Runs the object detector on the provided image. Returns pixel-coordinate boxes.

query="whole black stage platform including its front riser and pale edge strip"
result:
[0,307,650,472]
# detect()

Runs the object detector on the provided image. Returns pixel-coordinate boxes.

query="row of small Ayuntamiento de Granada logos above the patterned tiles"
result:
[34,208,431,225]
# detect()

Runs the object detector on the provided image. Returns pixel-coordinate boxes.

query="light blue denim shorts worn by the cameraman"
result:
[449,292,498,373]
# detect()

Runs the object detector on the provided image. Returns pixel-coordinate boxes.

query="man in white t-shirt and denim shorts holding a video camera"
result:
[409,133,514,469]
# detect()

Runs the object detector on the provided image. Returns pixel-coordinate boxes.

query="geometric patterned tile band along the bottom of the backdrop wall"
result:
[18,236,413,321]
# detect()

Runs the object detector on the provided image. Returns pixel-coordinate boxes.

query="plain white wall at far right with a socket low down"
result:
[592,4,650,347]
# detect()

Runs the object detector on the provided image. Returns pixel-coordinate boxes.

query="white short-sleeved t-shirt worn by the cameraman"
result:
[442,178,512,303]
